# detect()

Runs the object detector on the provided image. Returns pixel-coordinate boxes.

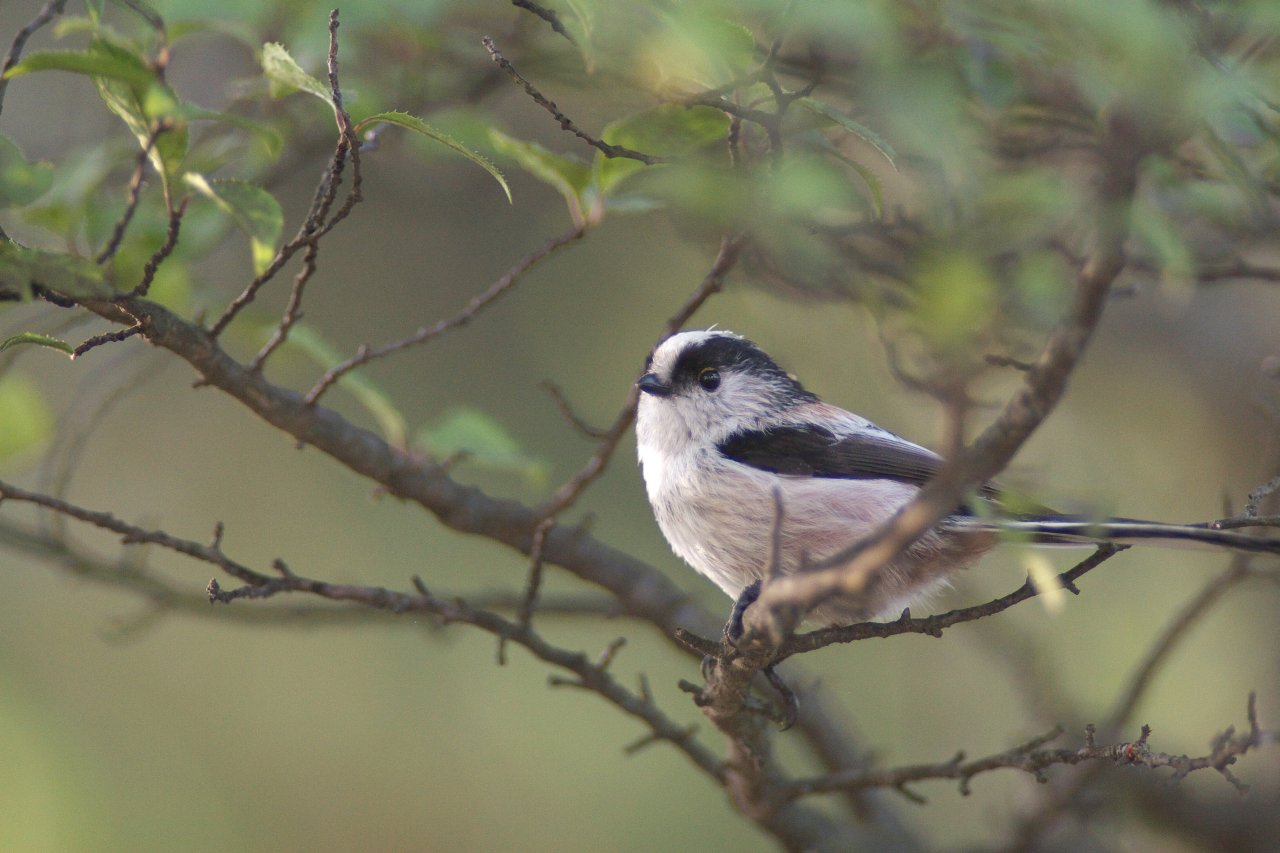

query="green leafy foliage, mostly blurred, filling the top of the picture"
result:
[0,0,1280,845]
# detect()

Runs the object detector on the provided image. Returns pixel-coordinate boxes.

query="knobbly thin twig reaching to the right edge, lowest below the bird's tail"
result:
[788,693,1276,802]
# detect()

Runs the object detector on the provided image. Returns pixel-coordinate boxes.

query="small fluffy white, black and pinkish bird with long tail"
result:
[636,330,1280,626]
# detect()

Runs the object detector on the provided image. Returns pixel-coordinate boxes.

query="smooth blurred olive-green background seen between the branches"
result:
[0,1,1280,850]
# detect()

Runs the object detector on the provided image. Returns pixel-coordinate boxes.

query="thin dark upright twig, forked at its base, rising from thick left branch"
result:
[209,9,364,338]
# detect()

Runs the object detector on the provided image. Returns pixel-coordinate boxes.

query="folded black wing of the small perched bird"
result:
[718,427,942,485]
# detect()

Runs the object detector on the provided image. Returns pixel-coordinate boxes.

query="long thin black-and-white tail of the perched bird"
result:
[961,515,1280,555]
